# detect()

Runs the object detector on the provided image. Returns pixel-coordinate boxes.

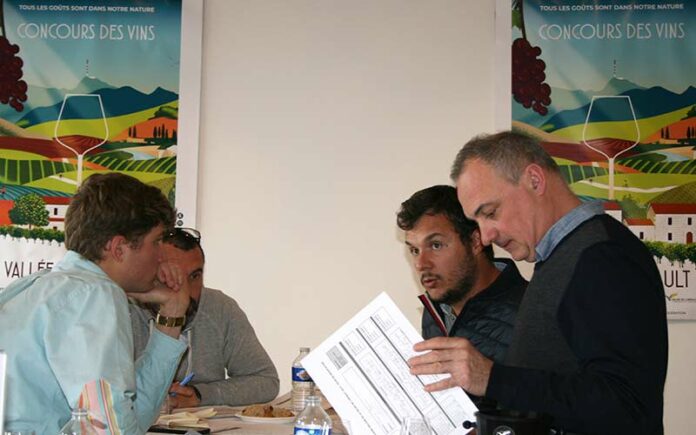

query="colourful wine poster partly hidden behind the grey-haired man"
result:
[496,0,696,319]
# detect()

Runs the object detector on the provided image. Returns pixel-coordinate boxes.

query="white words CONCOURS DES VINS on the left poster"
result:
[17,22,156,41]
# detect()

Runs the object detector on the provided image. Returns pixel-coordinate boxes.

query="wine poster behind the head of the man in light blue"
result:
[0,0,202,288]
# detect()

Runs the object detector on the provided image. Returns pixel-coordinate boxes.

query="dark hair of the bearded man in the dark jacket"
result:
[396,185,493,260]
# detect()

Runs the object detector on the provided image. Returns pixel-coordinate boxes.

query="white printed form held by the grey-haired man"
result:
[302,293,476,435]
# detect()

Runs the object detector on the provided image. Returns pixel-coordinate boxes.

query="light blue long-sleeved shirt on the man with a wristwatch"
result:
[0,251,186,435]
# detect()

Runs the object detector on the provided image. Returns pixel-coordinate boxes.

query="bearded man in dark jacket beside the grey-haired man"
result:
[397,186,527,361]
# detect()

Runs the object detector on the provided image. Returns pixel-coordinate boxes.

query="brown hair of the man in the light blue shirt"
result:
[65,172,175,261]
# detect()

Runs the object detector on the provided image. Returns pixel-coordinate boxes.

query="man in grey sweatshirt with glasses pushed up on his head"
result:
[131,228,279,408]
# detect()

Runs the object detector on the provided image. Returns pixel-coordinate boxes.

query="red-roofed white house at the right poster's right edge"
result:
[647,204,696,243]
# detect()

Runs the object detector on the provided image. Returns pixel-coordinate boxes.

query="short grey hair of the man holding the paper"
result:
[450,131,560,184]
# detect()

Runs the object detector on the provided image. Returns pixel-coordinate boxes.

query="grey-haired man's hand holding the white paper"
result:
[408,337,493,396]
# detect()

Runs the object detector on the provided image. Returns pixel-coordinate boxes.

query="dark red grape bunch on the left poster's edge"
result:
[0,36,27,112]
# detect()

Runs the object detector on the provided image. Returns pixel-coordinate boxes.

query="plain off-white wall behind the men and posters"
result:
[198,0,696,434]
